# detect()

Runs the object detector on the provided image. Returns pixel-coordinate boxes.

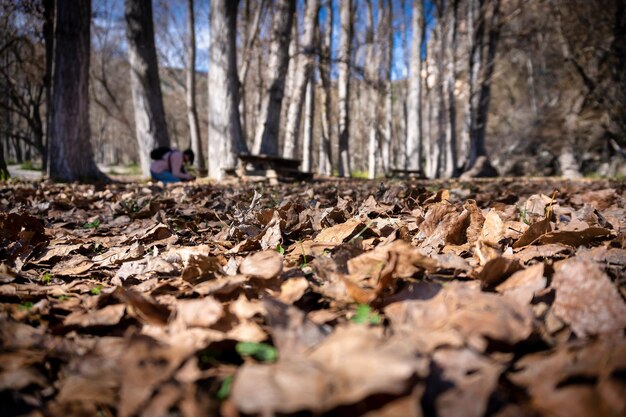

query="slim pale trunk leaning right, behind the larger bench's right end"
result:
[283,0,320,158]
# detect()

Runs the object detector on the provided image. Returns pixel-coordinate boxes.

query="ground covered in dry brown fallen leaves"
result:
[0,179,626,417]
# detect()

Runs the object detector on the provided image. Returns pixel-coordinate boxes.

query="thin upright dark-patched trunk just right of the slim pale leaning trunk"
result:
[318,3,334,176]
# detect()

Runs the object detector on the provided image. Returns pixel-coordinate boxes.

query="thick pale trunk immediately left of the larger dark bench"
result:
[208,0,248,180]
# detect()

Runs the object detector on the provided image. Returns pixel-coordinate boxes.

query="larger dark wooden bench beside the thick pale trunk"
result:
[230,154,313,184]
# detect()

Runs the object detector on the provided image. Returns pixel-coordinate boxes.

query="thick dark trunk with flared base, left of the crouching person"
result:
[48,0,106,181]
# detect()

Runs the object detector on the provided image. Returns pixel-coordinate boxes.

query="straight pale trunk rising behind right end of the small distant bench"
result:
[406,0,424,170]
